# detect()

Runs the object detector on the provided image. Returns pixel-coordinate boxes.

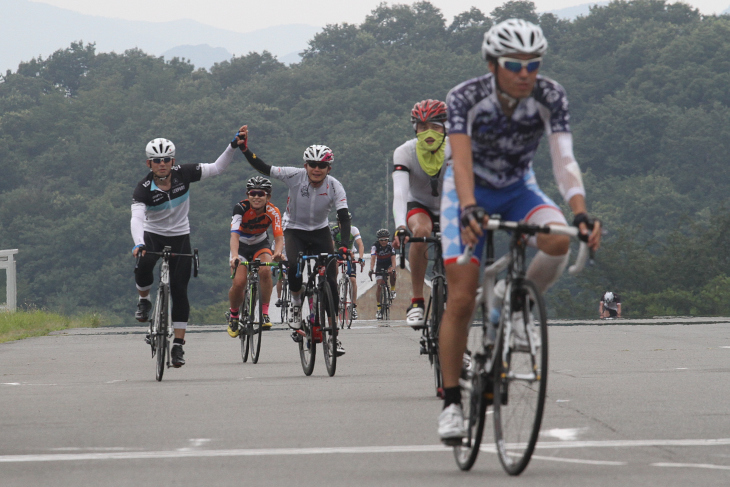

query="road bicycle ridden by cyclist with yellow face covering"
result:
[398,230,447,398]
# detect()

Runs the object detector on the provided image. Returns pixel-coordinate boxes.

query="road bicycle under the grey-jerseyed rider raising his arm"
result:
[295,252,350,377]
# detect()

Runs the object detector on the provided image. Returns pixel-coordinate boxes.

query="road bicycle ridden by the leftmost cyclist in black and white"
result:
[137,246,200,382]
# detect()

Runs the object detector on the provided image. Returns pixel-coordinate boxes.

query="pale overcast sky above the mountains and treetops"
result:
[32,0,730,32]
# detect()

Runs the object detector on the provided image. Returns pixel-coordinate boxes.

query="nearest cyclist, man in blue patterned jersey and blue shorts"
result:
[438,19,601,443]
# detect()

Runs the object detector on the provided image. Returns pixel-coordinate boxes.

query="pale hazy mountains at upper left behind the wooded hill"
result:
[0,0,320,73]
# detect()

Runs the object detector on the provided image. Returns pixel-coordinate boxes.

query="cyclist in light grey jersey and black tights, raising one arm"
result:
[236,125,350,355]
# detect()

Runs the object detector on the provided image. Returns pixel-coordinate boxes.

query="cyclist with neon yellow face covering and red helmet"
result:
[393,100,451,326]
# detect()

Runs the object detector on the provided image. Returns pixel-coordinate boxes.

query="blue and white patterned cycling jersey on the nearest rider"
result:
[446,73,570,188]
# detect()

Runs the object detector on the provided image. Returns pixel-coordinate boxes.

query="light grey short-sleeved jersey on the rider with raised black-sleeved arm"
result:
[271,166,347,231]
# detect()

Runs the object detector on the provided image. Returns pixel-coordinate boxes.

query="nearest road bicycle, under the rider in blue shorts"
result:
[454,219,589,475]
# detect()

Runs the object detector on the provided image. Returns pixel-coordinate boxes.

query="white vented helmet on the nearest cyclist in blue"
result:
[482,19,547,61]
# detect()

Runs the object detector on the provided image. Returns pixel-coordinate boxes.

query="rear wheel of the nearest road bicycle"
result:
[454,356,487,470]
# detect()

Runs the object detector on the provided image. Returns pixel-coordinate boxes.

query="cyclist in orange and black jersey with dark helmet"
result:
[228,176,284,338]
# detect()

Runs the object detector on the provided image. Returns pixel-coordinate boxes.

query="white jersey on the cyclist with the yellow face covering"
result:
[393,137,451,228]
